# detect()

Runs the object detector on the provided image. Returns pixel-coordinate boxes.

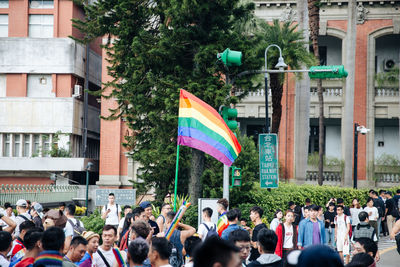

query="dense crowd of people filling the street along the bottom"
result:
[0,190,400,267]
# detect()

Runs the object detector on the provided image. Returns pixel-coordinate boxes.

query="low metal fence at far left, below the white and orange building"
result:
[0,184,79,204]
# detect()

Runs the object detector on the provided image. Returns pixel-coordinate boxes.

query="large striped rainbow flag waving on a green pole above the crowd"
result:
[178,89,242,166]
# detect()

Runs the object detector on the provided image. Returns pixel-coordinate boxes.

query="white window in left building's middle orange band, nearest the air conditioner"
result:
[27,74,56,97]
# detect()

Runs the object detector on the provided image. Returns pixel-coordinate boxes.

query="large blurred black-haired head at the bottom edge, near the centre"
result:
[193,236,241,267]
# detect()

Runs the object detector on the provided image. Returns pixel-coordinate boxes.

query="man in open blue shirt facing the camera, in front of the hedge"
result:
[297,204,325,248]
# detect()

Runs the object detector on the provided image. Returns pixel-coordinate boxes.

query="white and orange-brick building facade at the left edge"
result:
[0,0,102,184]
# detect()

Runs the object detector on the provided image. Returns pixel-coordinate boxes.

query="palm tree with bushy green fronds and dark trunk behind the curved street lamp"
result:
[259,20,315,133]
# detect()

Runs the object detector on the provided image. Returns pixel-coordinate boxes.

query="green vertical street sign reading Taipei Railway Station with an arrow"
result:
[258,134,279,188]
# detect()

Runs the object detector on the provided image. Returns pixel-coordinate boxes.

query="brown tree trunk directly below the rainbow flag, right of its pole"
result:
[189,149,204,204]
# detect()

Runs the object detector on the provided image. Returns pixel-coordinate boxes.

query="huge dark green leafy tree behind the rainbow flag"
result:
[75,0,262,201]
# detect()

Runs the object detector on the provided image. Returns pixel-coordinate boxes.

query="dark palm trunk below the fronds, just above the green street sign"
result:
[269,73,283,134]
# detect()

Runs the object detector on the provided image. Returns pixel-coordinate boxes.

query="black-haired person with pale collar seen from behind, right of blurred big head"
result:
[248,229,283,267]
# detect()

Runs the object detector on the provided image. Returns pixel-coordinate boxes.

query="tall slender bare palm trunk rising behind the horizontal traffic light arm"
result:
[308,0,325,185]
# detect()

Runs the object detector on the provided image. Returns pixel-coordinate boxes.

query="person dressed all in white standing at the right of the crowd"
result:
[335,205,351,264]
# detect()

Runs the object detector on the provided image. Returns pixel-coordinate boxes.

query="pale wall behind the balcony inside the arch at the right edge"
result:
[375,127,400,159]
